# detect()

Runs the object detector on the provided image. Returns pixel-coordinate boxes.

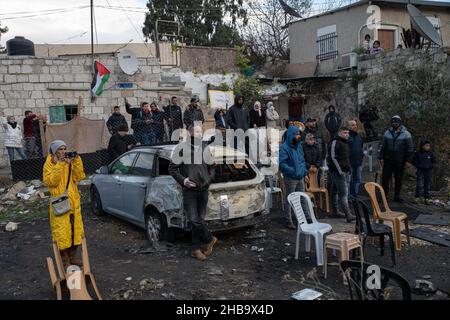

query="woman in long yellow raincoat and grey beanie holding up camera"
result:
[43,140,86,268]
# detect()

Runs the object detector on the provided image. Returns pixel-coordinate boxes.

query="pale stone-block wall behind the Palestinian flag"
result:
[0,55,190,168]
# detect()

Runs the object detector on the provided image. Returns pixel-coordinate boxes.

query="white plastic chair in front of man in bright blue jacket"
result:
[288,192,332,266]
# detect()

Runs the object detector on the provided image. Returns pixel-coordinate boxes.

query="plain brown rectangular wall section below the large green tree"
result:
[180,47,239,74]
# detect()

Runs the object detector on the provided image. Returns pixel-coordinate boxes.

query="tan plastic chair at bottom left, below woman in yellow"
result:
[47,238,102,300]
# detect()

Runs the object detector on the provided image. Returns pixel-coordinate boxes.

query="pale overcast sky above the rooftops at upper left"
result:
[0,0,450,46]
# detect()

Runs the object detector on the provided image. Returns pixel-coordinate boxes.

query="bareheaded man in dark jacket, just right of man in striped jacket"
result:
[348,120,364,196]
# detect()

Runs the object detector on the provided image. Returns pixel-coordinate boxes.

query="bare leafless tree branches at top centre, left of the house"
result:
[241,0,312,63]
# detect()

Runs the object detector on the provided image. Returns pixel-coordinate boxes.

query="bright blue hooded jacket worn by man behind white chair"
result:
[279,126,308,179]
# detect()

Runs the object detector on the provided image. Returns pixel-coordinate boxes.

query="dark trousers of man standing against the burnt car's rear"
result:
[183,189,213,251]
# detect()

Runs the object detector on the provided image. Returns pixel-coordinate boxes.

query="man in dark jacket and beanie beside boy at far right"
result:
[379,116,414,202]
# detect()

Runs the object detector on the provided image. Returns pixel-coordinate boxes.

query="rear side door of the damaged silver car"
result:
[122,151,155,226]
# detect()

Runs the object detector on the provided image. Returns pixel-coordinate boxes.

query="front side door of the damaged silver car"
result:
[97,152,137,215]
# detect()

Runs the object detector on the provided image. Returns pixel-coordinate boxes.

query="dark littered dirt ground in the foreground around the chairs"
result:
[0,189,450,300]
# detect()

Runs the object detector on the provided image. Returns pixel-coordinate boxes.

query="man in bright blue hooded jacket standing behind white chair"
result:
[279,126,308,229]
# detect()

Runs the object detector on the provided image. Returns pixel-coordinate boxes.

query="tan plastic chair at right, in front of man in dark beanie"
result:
[364,182,411,251]
